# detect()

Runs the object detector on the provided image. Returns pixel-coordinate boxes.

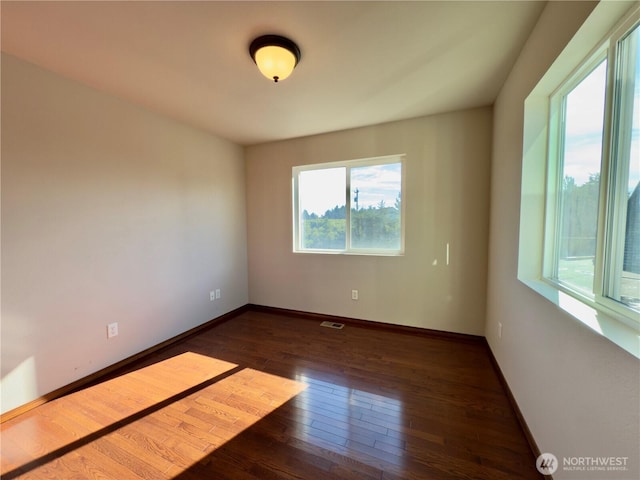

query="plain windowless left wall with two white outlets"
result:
[1,51,248,412]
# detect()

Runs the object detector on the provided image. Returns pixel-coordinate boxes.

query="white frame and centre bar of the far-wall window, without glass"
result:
[292,154,406,256]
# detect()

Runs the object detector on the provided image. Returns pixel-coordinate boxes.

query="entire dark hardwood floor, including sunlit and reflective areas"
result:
[0,311,543,480]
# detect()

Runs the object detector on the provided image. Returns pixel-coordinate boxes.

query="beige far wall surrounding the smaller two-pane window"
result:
[245,108,492,335]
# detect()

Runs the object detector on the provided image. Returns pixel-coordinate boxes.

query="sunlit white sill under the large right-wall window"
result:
[520,279,640,359]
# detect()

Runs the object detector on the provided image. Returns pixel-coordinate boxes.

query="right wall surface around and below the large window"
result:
[486,2,640,480]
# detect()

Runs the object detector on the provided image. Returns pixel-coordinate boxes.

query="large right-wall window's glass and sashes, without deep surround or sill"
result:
[544,16,640,317]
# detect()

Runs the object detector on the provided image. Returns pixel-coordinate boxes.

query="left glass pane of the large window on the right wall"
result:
[545,56,607,294]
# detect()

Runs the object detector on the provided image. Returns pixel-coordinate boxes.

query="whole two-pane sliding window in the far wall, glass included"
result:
[293,155,404,255]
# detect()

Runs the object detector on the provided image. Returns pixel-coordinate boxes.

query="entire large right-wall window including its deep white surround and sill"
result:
[518,2,640,356]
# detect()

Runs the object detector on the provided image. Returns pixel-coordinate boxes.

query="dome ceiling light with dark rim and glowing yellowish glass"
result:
[249,35,300,83]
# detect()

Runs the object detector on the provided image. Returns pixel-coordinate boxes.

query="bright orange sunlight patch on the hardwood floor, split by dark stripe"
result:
[0,352,306,479]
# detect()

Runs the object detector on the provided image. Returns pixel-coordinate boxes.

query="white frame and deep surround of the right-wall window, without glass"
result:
[518,2,640,358]
